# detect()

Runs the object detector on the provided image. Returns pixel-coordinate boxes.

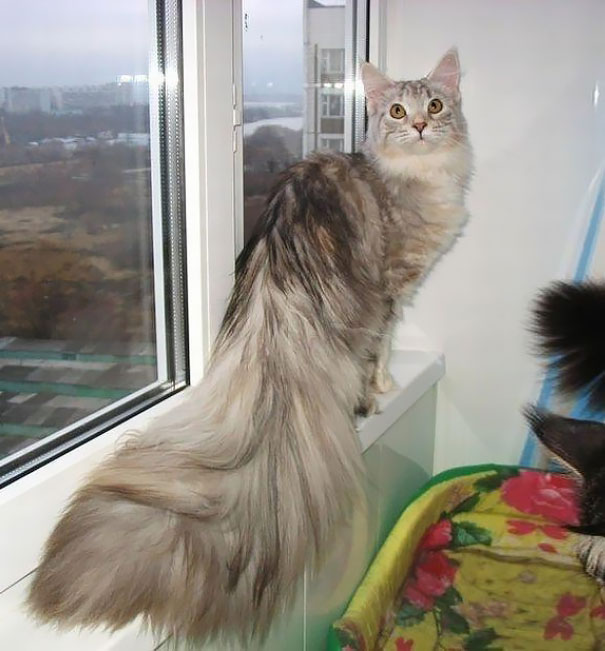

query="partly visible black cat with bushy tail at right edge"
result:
[526,282,605,582]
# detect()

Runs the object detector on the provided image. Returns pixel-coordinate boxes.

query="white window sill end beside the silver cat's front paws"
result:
[358,350,445,452]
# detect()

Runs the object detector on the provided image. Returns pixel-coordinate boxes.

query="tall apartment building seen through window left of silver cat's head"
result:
[303,0,345,154]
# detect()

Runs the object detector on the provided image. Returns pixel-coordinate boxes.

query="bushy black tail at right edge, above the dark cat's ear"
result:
[534,282,605,410]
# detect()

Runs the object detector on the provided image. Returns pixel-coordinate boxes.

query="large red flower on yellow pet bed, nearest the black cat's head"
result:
[500,470,578,524]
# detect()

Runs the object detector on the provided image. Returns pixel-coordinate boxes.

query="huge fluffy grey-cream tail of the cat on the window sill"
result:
[29,244,361,639]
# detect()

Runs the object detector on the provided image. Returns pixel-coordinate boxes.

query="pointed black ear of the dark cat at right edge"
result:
[524,407,605,475]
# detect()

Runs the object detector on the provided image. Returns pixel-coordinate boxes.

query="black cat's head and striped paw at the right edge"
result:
[526,408,605,581]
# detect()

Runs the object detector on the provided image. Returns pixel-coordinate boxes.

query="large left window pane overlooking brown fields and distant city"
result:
[0,0,187,482]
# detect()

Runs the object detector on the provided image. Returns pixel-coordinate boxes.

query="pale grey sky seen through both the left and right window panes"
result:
[0,0,344,95]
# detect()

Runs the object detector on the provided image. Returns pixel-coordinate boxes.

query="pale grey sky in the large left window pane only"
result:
[0,0,149,86]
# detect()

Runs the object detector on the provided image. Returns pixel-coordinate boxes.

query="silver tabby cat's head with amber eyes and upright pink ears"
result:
[361,49,468,172]
